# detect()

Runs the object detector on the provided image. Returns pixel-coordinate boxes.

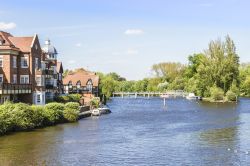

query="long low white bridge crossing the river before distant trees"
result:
[113,90,188,98]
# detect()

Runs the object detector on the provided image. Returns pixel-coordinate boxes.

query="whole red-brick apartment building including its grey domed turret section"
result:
[0,31,63,105]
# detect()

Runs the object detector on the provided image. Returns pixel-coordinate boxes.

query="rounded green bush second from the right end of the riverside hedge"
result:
[44,103,64,125]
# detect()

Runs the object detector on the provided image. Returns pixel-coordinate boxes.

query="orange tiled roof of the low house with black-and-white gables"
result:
[63,69,99,86]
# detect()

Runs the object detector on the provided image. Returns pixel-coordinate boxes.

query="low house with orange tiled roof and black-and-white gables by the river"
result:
[63,69,99,97]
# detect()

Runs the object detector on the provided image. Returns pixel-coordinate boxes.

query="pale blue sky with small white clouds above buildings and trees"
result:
[0,0,250,79]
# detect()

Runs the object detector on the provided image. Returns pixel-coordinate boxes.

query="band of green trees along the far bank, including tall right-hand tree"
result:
[94,36,250,102]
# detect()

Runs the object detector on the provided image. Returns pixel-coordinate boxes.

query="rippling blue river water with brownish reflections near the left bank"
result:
[0,98,250,166]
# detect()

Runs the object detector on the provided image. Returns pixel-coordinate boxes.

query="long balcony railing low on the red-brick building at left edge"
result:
[0,83,32,94]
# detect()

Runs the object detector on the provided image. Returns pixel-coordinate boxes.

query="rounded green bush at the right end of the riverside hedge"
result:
[63,102,79,122]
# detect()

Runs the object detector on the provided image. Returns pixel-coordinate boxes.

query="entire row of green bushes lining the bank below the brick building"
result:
[0,102,80,135]
